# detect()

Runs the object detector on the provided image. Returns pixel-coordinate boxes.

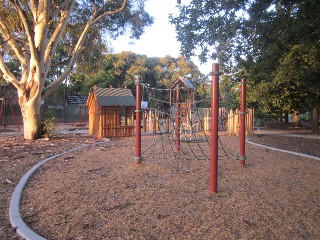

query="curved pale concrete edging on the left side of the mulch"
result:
[9,139,110,240]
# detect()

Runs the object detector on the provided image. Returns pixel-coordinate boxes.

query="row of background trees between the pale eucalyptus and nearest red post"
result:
[46,51,210,105]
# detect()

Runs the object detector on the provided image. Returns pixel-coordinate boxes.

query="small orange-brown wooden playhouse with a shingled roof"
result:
[87,87,136,138]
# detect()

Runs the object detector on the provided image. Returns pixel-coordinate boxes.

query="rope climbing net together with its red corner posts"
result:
[134,64,247,192]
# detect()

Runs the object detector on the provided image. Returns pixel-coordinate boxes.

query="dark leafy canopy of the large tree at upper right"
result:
[171,0,320,117]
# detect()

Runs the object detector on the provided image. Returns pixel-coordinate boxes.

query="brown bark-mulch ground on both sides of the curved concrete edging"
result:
[0,124,320,240]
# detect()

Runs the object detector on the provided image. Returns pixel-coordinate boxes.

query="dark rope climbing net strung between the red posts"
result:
[141,84,235,169]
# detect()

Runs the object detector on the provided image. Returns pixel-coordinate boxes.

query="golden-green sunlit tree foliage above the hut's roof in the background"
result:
[71,52,206,97]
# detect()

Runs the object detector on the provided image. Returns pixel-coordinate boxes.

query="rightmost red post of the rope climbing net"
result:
[239,79,246,167]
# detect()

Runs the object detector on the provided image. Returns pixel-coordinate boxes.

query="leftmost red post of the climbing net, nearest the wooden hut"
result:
[134,76,142,165]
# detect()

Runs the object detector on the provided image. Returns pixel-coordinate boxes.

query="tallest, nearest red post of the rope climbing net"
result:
[210,63,220,193]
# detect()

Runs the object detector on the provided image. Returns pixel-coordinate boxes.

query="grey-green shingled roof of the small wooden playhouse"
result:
[93,87,136,107]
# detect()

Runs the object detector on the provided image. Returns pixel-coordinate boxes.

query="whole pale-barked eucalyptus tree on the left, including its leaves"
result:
[0,0,152,139]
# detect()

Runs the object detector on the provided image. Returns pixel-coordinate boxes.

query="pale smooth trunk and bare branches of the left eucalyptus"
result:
[0,0,127,140]
